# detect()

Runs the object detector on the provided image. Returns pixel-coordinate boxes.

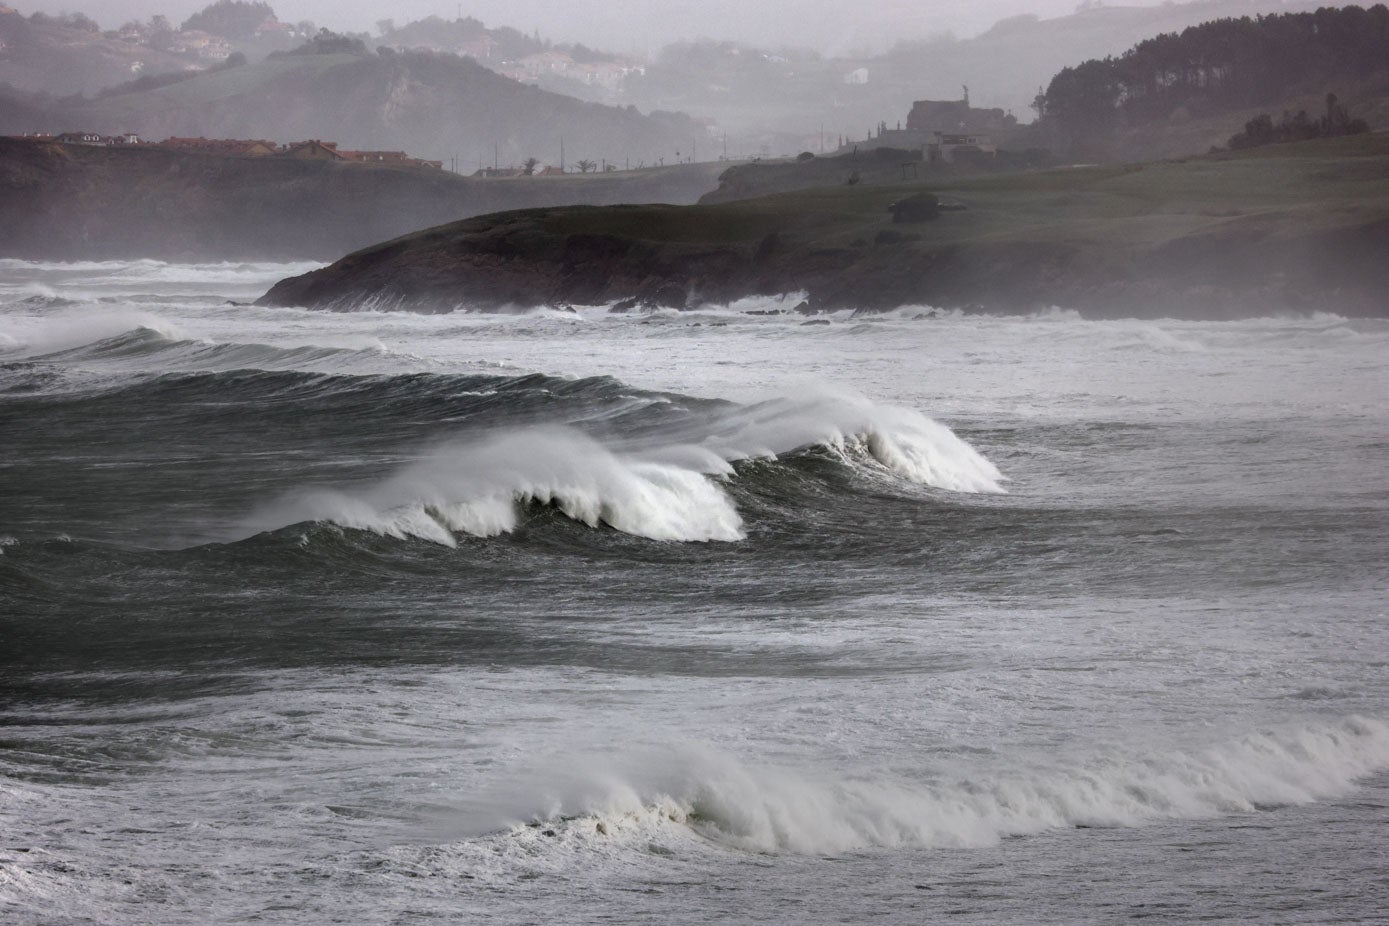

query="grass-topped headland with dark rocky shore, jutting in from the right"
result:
[263,133,1389,317]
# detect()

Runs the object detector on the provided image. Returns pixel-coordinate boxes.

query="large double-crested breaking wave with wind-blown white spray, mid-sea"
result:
[249,394,1003,547]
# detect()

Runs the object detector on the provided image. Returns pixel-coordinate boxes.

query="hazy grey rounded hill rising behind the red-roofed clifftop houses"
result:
[17,35,704,167]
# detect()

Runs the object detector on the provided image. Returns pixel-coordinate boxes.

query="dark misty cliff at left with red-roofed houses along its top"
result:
[0,139,715,260]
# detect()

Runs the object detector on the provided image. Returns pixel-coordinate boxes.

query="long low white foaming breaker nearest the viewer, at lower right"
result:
[471,716,1389,854]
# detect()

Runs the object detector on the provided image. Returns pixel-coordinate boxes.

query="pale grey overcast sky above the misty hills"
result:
[27,0,1149,53]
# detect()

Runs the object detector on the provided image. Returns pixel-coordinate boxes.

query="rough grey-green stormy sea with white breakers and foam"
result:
[0,261,1389,926]
